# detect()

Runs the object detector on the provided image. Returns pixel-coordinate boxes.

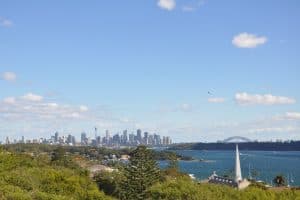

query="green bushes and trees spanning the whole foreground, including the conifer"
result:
[0,146,300,200]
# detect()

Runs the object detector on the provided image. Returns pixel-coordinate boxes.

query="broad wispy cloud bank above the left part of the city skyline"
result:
[0,93,136,140]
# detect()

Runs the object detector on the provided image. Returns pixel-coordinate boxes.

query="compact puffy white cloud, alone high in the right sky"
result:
[232,33,267,48]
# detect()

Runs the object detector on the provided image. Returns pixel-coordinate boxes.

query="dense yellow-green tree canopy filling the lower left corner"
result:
[0,148,110,200]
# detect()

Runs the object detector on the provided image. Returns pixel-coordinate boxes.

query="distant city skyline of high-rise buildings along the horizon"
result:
[1,128,172,147]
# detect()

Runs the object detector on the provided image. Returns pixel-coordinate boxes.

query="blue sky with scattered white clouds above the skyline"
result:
[0,0,300,142]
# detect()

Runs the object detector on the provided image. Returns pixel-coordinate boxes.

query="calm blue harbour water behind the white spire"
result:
[160,150,300,186]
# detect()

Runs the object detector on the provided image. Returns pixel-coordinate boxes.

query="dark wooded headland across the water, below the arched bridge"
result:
[170,141,300,151]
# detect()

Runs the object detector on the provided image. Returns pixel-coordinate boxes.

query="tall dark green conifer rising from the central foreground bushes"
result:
[120,146,160,200]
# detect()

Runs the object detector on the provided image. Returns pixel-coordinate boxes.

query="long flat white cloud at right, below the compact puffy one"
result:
[235,92,296,105]
